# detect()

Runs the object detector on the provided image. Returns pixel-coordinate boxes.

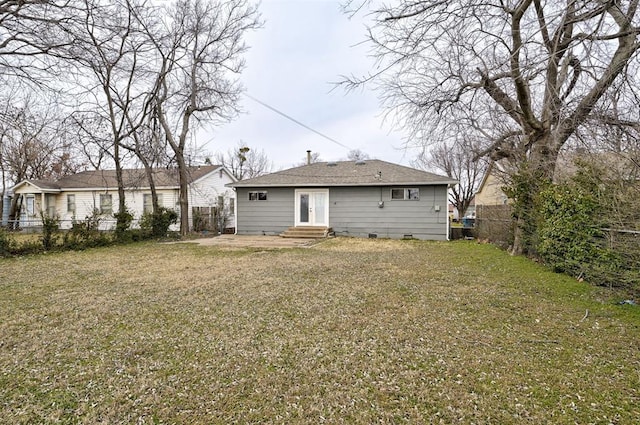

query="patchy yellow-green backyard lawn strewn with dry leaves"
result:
[0,238,640,424]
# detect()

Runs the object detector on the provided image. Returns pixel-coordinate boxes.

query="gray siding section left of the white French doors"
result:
[236,187,295,235]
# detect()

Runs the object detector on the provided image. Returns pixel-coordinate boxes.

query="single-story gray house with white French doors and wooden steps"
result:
[227,160,457,240]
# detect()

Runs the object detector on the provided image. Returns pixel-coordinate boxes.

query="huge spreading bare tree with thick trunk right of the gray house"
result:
[344,0,640,253]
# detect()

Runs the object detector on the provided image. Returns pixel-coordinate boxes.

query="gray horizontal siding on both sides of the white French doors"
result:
[237,185,449,240]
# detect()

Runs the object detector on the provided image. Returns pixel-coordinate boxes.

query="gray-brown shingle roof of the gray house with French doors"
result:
[227,159,458,187]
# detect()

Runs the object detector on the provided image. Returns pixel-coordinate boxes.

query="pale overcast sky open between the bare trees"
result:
[198,0,415,170]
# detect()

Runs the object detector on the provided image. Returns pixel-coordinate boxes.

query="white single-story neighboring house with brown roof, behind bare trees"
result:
[12,165,236,230]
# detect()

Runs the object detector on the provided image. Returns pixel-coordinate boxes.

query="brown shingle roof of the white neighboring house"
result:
[14,165,233,191]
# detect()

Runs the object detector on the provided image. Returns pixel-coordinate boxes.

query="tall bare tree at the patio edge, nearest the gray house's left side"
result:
[147,0,260,234]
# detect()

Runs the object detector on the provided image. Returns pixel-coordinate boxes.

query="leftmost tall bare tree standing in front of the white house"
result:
[69,0,157,230]
